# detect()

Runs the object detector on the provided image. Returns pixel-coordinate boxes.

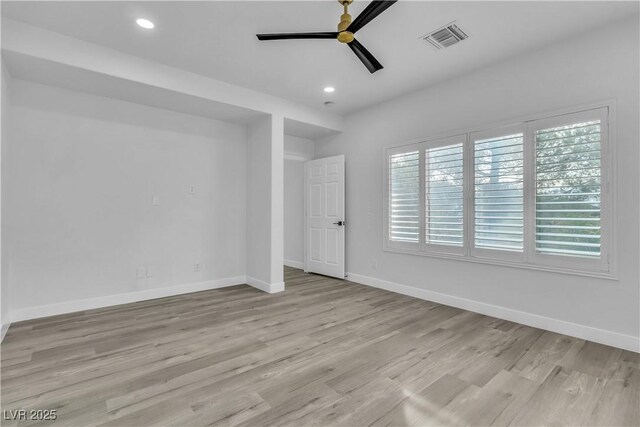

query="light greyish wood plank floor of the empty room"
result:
[2,268,640,426]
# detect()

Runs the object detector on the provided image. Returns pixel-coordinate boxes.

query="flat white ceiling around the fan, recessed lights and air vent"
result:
[2,0,638,113]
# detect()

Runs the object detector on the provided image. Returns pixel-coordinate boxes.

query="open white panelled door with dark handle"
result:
[304,156,345,279]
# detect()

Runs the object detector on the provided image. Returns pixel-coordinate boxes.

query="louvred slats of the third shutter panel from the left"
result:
[473,133,524,252]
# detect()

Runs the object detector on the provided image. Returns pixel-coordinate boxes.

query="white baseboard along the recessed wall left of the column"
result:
[13,276,246,322]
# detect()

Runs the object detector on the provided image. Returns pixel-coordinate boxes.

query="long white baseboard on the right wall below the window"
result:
[347,273,640,353]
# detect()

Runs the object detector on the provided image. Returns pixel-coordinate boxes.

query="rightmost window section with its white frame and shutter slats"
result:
[531,109,611,270]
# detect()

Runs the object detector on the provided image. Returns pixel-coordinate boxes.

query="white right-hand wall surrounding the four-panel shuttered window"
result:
[316,16,640,348]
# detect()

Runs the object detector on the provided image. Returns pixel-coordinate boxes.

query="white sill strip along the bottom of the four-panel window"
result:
[383,246,618,281]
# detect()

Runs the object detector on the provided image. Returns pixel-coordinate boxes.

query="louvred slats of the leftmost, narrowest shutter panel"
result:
[389,150,420,243]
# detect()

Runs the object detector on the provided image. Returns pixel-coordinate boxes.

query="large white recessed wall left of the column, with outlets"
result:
[2,79,247,318]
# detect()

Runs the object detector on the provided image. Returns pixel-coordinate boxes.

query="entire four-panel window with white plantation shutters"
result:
[386,107,612,276]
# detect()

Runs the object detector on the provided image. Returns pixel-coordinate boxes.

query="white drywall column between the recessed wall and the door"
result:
[246,116,284,293]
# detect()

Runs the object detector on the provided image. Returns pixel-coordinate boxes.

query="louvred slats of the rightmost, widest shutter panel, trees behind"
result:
[535,120,602,258]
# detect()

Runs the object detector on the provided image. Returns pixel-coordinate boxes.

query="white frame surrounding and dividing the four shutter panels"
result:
[382,100,617,280]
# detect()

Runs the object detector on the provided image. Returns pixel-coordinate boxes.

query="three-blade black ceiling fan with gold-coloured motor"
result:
[256,0,397,74]
